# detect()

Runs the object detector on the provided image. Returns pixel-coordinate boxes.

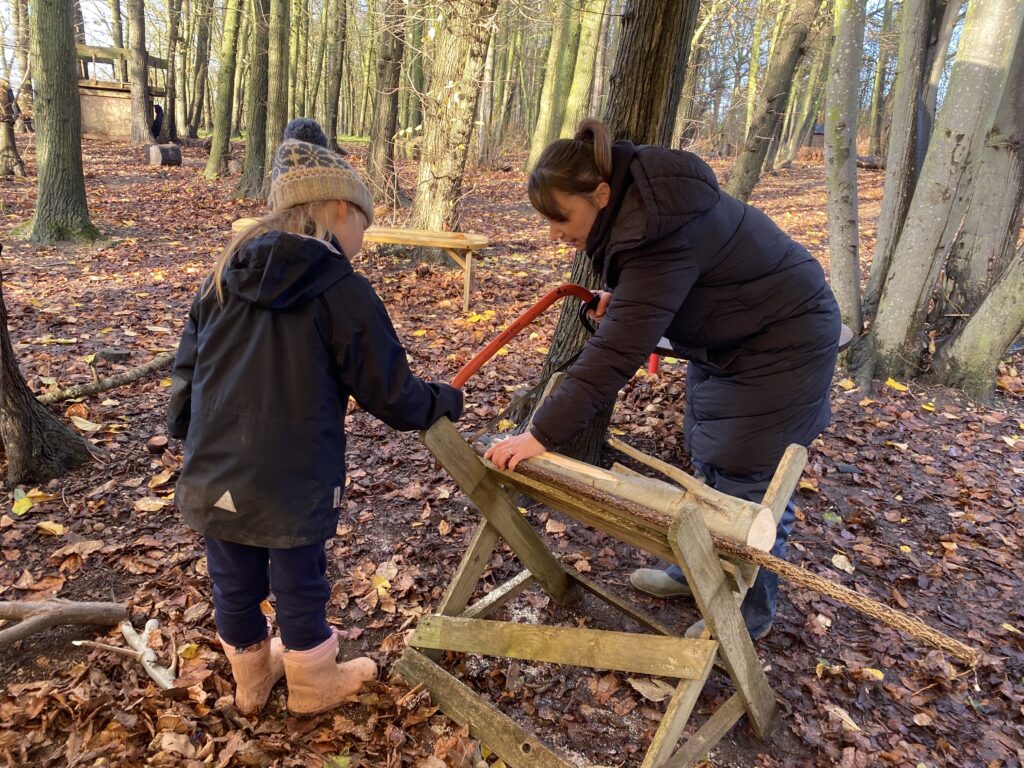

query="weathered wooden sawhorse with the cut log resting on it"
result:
[395,419,807,768]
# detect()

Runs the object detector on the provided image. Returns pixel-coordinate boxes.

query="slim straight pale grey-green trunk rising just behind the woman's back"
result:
[825,0,864,335]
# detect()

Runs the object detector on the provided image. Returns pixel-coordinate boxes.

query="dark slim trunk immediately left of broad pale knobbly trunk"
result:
[367,0,410,208]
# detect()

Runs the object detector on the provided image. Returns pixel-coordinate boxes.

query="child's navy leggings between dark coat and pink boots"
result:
[206,537,331,650]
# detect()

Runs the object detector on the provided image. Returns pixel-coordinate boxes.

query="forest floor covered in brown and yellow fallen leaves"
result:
[0,135,1024,768]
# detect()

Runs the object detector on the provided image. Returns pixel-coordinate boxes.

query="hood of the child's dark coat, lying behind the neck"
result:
[223,231,352,309]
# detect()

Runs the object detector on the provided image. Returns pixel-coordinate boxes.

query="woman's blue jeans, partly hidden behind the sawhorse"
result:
[666,462,797,637]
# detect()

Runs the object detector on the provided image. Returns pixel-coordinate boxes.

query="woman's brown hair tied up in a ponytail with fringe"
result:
[527,118,611,221]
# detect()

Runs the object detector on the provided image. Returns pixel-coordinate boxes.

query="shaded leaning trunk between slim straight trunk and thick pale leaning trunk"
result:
[864,0,936,316]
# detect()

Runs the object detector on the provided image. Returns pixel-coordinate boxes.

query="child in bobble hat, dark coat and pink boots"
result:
[167,119,462,714]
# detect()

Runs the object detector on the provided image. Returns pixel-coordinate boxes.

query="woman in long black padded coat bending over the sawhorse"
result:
[486,120,841,639]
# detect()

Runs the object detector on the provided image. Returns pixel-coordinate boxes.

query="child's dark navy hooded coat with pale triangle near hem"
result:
[167,232,462,548]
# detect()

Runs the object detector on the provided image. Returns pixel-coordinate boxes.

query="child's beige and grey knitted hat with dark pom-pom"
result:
[267,118,374,225]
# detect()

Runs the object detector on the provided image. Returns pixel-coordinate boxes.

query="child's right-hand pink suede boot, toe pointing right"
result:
[285,634,377,715]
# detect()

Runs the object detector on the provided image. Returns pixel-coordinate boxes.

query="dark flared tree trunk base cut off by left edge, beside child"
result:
[0,259,92,487]
